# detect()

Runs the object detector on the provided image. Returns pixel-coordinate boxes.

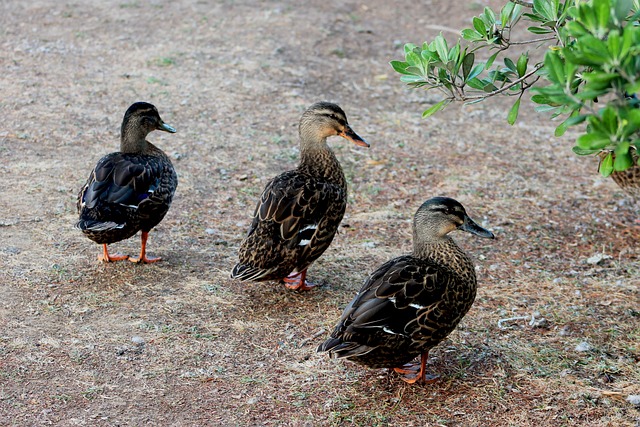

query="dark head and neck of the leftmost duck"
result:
[121,102,176,151]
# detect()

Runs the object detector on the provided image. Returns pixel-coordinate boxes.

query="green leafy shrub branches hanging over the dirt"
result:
[391,0,640,176]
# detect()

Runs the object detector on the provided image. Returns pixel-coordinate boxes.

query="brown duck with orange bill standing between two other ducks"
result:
[230,102,369,291]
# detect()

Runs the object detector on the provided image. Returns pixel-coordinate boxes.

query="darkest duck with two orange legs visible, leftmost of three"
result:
[75,102,178,264]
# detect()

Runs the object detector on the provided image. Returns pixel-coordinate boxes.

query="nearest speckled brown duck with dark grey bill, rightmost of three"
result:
[317,196,495,383]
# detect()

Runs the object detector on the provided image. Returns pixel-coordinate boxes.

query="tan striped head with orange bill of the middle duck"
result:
[300,102,369,147]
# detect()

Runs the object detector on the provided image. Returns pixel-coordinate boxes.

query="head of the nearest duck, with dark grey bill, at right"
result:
[413,197,495,242]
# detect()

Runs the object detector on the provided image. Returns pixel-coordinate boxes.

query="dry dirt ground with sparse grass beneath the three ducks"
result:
[0,0,640,427]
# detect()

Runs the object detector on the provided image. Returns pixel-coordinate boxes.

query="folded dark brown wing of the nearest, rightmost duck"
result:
[318,256,452,357]
